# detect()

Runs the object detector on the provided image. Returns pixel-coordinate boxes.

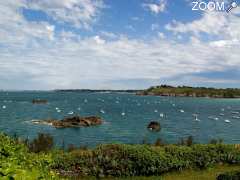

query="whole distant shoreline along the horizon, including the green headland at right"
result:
[0,85,240,99]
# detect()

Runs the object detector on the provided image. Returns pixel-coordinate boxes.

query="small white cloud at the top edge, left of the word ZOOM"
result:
[142,0,167,14]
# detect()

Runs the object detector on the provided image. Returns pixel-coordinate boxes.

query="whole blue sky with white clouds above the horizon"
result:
[0,0,240,90]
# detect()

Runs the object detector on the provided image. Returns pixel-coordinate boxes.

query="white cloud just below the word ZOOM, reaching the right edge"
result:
[165,8,240,39]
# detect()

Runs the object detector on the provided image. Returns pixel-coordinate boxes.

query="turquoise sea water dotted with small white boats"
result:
[0,91,240,146]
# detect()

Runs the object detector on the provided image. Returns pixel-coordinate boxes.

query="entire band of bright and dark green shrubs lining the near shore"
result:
[0,134,240,179]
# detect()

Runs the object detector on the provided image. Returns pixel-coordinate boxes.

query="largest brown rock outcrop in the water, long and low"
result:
[32,116,103,128]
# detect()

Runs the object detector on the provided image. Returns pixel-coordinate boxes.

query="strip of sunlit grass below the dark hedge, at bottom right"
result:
[81,165,240,180]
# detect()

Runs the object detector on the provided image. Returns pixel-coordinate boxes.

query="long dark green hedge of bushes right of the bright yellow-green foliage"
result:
[52,144,240,177]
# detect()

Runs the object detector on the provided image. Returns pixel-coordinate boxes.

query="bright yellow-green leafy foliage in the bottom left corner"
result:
[0,134,56,180]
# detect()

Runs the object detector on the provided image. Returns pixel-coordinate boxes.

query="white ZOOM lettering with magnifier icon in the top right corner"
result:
[192,1,238,13]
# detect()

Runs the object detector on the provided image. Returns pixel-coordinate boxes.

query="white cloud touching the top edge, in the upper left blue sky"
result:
[25,0,104,28]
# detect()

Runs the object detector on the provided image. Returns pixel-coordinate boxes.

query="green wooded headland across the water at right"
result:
[137,85,240,98]
